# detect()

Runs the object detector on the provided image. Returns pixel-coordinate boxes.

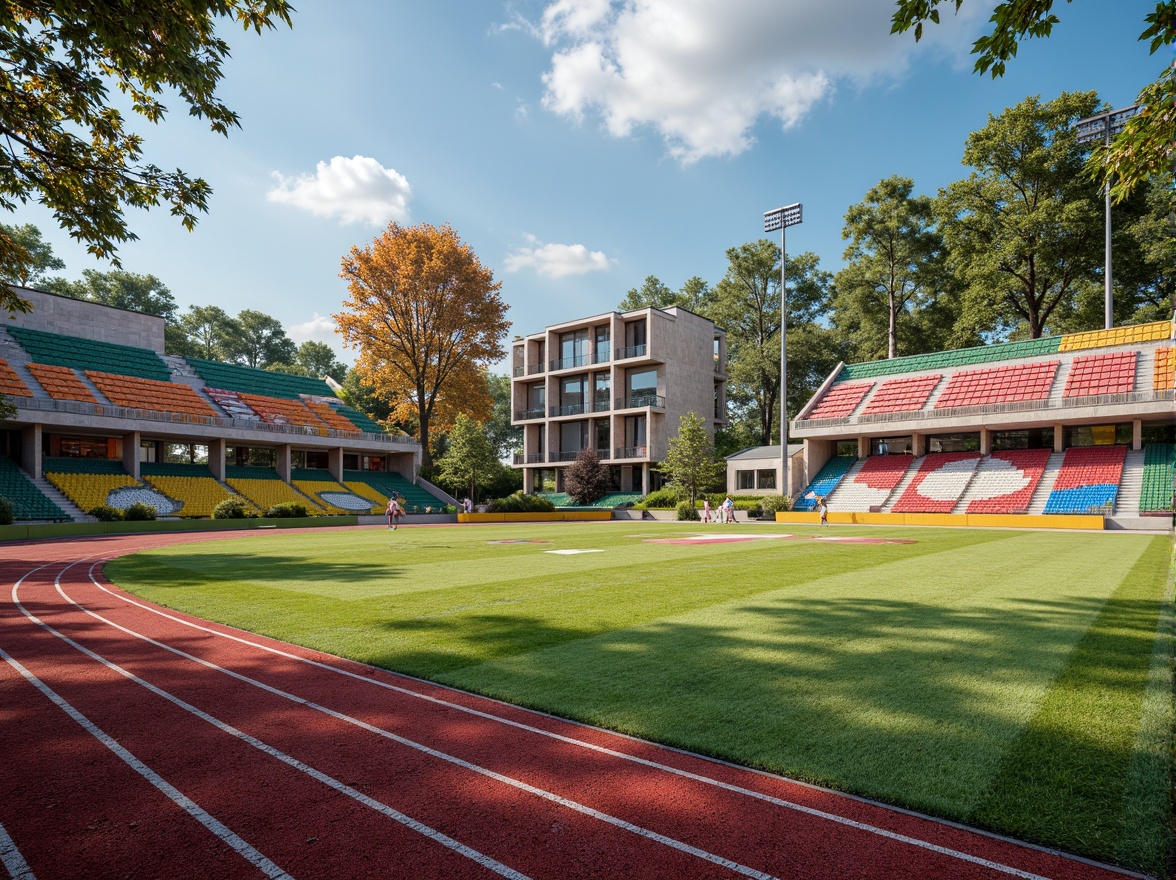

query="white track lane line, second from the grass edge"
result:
[56,564,777,880]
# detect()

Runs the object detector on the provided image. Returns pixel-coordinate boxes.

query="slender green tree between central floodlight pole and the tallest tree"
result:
[833,175,946,360]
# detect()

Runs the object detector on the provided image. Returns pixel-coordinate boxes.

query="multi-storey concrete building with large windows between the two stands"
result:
[512,307,727,493]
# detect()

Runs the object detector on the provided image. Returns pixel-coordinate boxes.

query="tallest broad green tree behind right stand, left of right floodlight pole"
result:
[936,92,1103,339]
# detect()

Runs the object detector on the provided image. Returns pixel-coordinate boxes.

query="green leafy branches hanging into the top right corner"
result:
[890,0,1176,204]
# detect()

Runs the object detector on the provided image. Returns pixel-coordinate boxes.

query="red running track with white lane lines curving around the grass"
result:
[0,534,1143,880]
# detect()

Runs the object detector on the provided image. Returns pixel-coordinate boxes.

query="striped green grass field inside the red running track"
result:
[107,522,1172,874]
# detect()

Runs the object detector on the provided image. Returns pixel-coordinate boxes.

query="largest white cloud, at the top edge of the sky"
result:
[529,0,991,164]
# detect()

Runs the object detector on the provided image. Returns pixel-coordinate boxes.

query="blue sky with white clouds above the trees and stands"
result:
[14,0,1168,362]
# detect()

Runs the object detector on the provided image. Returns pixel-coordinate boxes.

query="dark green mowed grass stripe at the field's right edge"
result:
[974,544,1171,872]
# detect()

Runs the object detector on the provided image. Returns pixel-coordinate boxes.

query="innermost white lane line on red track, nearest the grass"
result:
[82,561,1063,880]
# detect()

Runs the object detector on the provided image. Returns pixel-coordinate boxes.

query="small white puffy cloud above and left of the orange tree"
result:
[266,155,413,226]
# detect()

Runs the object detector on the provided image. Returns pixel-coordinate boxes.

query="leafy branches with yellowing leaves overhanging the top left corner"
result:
[0,0,293,311]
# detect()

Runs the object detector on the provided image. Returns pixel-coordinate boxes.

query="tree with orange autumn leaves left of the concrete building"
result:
[334,224,510,468]
